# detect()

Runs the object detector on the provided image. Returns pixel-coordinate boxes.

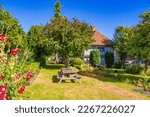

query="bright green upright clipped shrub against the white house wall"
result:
[90,50,100,66]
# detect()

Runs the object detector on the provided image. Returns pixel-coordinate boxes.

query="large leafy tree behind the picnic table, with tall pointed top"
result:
[44,1,93,67]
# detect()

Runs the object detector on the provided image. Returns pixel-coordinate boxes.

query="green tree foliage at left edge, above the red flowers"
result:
[0,8,27,49]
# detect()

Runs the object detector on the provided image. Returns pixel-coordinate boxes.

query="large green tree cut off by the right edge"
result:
[128,10,150,72]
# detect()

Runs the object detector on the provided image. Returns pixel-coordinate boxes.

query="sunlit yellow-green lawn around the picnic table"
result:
[21,65,150,100]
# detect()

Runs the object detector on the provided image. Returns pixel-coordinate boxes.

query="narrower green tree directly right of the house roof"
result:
[114,26,131,66]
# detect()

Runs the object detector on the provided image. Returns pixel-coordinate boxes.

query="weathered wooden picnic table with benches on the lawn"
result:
[57,68,81,84]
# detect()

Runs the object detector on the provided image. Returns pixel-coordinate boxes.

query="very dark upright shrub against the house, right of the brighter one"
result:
[105,52,114,68]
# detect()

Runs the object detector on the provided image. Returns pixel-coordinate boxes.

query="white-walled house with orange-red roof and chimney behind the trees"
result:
[84,26,113,65]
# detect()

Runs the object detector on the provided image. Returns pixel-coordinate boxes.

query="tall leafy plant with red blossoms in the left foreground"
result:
[0,34,33,100]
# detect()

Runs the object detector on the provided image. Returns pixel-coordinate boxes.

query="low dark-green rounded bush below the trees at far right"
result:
[126,64,143,74]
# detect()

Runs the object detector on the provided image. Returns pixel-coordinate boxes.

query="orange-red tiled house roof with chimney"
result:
[91,27,113,46]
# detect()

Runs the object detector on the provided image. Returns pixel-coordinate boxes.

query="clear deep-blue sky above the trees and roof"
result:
[0,0,150,39]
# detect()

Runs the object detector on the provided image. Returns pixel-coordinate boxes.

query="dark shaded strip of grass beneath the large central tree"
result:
[43,64,64,70]
